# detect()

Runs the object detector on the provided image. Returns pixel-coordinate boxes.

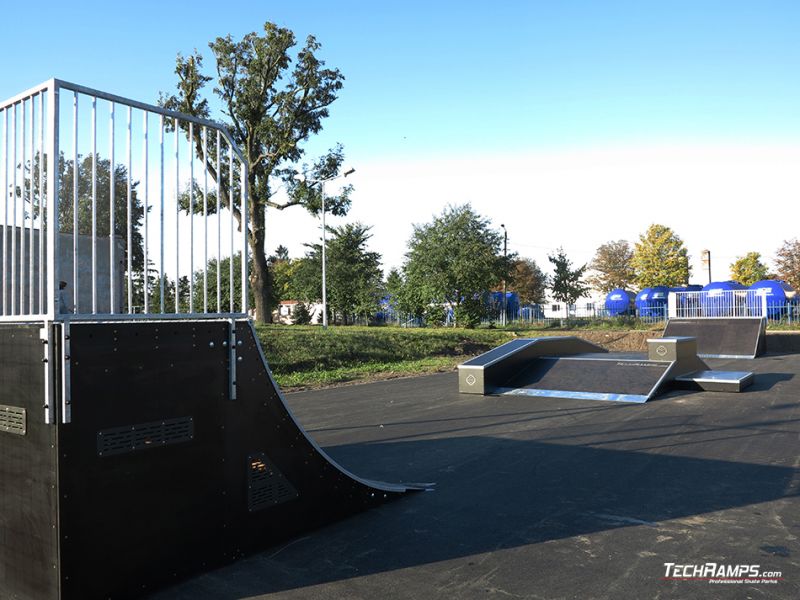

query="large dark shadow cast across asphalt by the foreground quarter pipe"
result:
[152,432,799,600]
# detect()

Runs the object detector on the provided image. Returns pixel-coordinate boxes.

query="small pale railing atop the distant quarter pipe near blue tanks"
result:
[667,289,768,319]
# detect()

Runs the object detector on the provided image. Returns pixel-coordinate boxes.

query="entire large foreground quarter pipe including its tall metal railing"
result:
[0,80,425,600]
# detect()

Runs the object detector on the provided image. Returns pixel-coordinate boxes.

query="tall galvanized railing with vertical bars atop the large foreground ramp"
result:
[0,79,248,321]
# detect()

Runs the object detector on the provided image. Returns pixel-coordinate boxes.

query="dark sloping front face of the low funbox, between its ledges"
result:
[508,357,670,399]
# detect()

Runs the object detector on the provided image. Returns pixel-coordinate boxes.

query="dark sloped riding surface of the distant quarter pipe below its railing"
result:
[664,318,764,358]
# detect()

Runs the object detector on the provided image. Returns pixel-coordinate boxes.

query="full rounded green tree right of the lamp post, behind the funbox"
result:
[404,204,504,325]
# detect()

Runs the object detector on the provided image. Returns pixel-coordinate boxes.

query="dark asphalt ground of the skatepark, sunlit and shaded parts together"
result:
[151,354,800,600]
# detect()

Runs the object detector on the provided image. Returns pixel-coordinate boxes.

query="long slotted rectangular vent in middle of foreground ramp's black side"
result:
[97,417,194,456]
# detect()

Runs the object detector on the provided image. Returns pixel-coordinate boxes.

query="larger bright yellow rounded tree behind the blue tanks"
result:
[633,224,692,288]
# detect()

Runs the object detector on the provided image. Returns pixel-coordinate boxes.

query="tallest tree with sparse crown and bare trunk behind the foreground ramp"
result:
[160,22,351,321]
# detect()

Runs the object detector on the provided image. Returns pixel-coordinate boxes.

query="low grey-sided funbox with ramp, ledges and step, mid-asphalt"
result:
[458,337,753,403]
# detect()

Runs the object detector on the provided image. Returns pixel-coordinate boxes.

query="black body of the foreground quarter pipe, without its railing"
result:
[0,321,424,600]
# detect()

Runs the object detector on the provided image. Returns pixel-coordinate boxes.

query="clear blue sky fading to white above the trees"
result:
[0,1,800,278]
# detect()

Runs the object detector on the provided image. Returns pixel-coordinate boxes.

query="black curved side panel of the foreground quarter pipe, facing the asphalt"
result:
[55,322,418,600]
